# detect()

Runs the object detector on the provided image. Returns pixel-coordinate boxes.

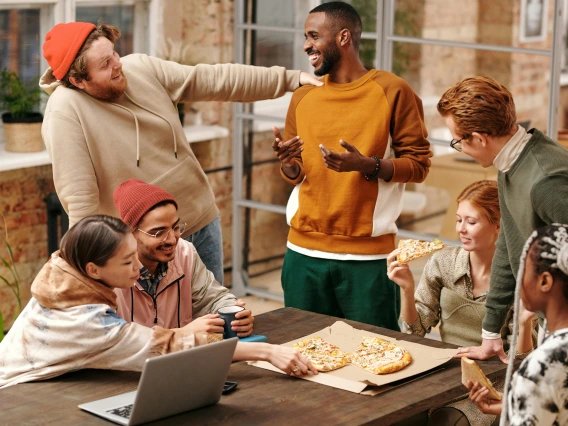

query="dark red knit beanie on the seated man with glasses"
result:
[112,179,177,229]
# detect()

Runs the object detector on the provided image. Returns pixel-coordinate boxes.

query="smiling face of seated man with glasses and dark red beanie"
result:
[134,203,180,271]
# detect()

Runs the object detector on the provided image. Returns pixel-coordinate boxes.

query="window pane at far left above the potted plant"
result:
[0,9,41,83]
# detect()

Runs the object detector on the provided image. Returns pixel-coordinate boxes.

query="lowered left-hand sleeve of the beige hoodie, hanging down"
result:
[41,107,99,226]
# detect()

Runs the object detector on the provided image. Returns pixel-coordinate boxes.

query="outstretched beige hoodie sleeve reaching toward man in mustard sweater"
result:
[140,55,300,102]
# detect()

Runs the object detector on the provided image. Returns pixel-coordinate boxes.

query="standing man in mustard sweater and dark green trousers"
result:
[273,2,431,330]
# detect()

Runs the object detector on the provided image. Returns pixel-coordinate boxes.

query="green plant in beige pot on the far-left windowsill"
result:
[0,69,44,152]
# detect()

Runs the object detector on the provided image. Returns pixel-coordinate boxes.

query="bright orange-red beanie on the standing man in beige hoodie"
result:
[43,22,97,80]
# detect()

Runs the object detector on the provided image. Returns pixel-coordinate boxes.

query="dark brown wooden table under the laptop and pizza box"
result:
[0,308,506,426]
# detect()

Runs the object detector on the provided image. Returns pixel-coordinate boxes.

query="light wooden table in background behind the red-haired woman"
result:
[425,153,498,240]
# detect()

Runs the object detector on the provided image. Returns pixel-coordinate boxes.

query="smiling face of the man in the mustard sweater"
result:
[304,12,341,76]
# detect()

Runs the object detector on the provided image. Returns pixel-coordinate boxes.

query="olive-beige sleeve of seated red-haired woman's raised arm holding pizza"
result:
[403,253,443,337]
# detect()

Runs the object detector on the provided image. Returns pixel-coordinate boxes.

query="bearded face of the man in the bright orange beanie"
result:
[73,37,127,102]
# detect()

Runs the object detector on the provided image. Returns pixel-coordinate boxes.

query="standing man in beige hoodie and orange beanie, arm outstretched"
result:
[40,22,321,283]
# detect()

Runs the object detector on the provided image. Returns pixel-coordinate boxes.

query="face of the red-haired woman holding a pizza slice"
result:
[456,200,499,252]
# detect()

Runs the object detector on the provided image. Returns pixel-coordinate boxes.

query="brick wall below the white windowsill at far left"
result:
[0,166,54,329]
